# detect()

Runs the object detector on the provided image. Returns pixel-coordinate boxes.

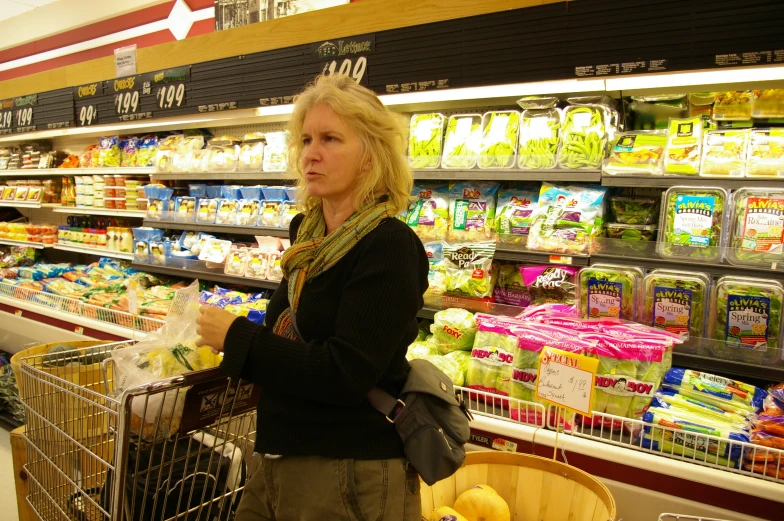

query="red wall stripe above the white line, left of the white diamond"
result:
[0,0,174,63]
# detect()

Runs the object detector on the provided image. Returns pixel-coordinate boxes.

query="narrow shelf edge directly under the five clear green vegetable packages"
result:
[414,168,601,183]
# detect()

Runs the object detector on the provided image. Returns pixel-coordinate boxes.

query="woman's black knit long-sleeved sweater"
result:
[221,215,428,459]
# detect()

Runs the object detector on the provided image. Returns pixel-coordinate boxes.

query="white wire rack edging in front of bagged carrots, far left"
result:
[0,282,164,333]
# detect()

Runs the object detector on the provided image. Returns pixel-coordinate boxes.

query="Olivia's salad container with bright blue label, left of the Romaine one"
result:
[656,186,728,261]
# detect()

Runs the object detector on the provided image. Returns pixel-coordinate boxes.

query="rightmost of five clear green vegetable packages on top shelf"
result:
[558,105,607,169]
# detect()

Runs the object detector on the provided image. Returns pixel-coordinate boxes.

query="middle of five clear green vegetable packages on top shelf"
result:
[478,110,520,168]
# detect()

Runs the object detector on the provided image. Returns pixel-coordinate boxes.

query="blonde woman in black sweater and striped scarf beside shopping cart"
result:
[198,75,428,521]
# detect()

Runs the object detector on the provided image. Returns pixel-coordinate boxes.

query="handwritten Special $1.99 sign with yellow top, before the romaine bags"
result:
[536,347,599,418]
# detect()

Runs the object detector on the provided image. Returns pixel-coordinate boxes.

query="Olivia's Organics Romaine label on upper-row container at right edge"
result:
[740,197,784,253]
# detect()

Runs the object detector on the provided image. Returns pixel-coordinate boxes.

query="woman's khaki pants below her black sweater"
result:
[235,456,422,521]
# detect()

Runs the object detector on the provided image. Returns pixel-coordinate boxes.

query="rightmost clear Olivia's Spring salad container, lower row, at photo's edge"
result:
[708,277,784,358]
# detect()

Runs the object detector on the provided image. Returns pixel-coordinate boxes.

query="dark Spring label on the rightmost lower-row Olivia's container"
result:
[726,295,770,349]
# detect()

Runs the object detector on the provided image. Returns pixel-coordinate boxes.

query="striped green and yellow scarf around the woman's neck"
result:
[273,197,395,340]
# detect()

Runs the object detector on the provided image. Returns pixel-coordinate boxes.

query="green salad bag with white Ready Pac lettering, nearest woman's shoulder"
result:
[444,242,495,299]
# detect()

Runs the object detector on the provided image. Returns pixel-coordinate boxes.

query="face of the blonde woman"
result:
[301,105,362,201]
